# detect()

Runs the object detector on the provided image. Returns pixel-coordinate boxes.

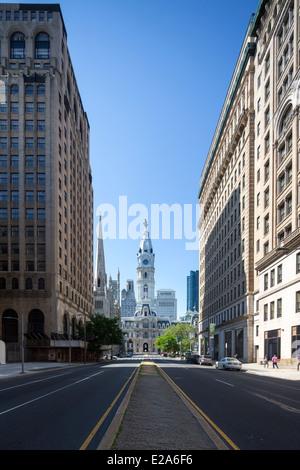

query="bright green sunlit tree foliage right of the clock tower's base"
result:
[155,323,195,352]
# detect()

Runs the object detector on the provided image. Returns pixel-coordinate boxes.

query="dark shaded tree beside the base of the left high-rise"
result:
[78,315,123,357]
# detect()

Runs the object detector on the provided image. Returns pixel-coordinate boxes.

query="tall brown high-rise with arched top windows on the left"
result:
[0,3,93,360]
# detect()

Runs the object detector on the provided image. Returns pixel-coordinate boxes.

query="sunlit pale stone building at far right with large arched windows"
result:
[251,0,300,362]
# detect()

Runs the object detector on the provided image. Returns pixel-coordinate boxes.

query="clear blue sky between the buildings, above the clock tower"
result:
[19,0,259,317]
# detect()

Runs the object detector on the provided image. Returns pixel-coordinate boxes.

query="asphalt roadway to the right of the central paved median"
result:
[157,361,300,450]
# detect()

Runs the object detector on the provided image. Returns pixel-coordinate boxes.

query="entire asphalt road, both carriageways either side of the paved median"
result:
[0,356,300,450]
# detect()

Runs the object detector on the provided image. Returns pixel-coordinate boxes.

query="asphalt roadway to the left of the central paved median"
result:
[0,362,137,450]
